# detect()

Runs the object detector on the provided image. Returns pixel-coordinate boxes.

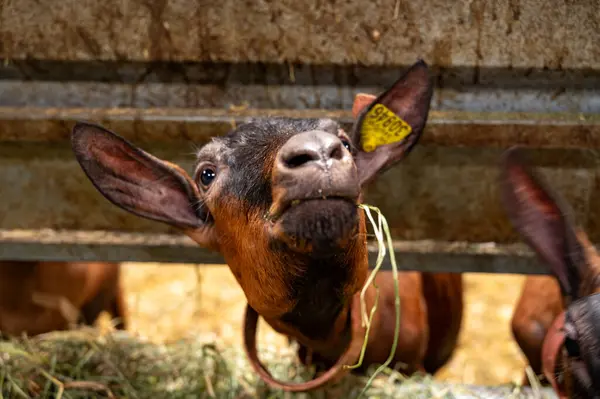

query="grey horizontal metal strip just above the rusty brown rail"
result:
[0,79,600,114]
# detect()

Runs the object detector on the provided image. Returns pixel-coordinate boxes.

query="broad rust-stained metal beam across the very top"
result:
[0,0,600,69]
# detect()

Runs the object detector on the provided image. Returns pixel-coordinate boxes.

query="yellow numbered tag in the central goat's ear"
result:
[360,104,412,152]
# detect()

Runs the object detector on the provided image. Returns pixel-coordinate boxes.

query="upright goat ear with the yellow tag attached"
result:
[352,61,433,185]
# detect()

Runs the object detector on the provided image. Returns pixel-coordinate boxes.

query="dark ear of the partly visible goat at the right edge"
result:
[500,147,588,299]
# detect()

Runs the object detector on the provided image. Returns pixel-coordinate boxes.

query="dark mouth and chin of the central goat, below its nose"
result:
[271,196,358,252]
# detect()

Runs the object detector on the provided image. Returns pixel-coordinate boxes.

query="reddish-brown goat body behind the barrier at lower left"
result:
[0,261,127,336]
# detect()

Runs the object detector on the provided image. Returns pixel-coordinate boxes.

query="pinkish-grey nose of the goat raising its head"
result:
[279,131,348,169]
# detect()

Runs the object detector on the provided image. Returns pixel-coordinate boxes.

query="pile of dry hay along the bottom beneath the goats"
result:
[0,328,552,399]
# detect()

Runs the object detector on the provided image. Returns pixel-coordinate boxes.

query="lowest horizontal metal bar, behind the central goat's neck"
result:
[0,230,548,274]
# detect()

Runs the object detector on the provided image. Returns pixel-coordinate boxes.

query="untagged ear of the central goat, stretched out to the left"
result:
[71,123,205,229]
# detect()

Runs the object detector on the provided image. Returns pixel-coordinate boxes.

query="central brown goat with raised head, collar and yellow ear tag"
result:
[72,61,463,391]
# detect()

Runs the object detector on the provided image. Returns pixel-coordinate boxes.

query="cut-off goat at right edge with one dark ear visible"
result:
[501,148,600,398]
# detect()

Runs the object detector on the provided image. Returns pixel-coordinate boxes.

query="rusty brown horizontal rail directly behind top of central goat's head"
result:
[0,107,600,149]
